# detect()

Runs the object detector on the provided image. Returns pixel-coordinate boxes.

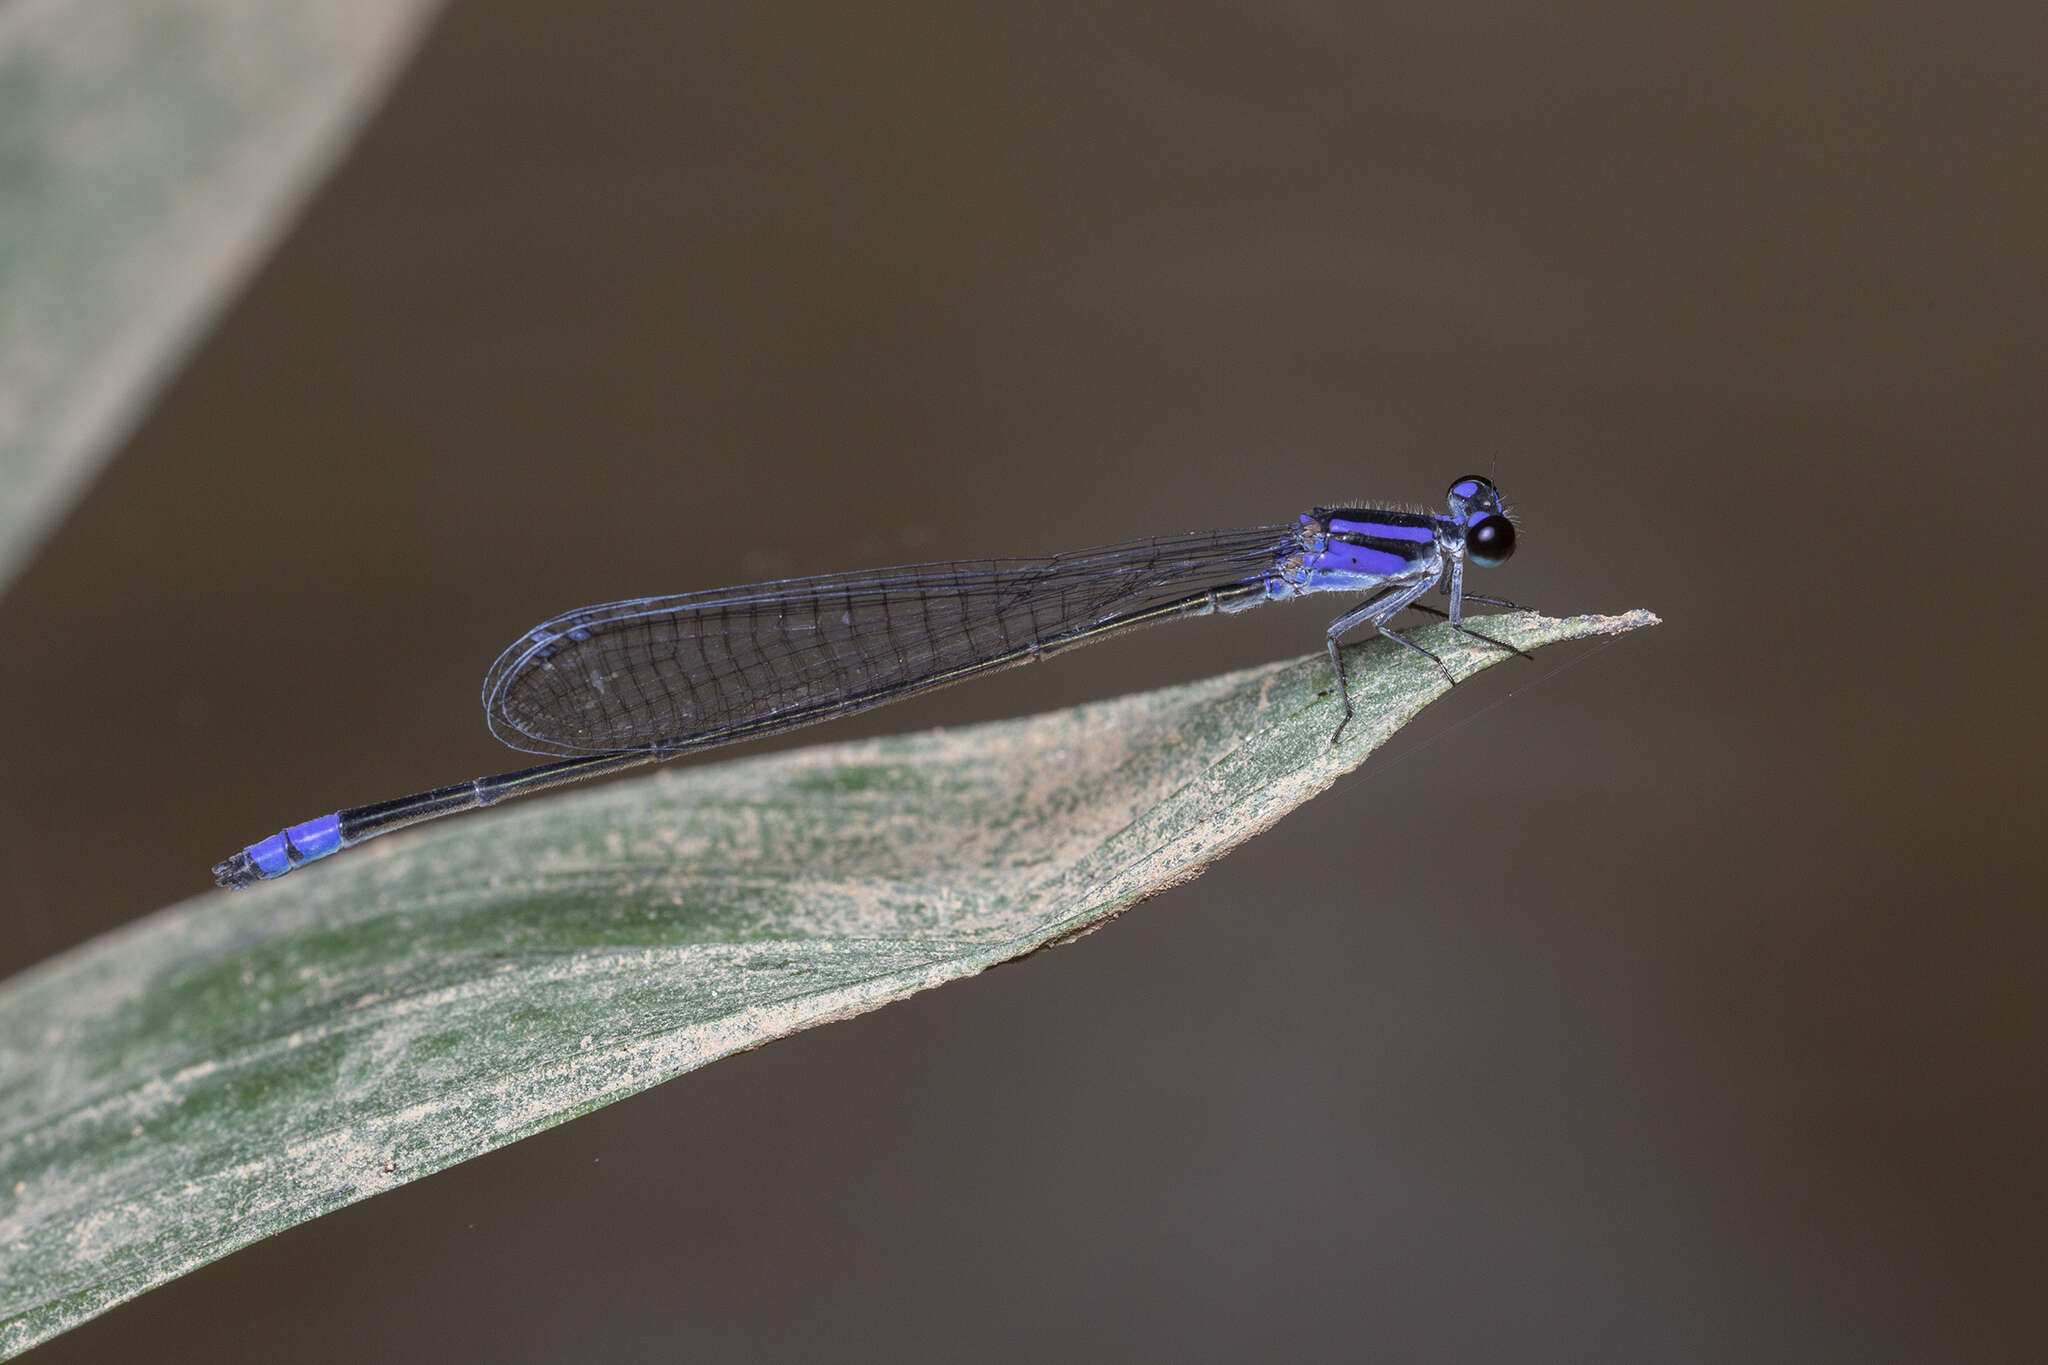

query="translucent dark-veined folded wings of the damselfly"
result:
[483,526,1298,757]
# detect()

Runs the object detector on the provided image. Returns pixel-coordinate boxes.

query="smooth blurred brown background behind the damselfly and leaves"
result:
[0,0,2048,1361]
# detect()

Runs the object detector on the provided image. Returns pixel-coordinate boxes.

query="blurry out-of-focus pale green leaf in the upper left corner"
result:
[0,0,438,585]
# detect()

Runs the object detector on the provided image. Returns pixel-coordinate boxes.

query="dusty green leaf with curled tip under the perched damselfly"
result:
[0,612,1657,1353]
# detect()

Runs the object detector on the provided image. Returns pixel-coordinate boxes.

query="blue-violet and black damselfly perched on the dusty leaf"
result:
[213,475,1520,886]
